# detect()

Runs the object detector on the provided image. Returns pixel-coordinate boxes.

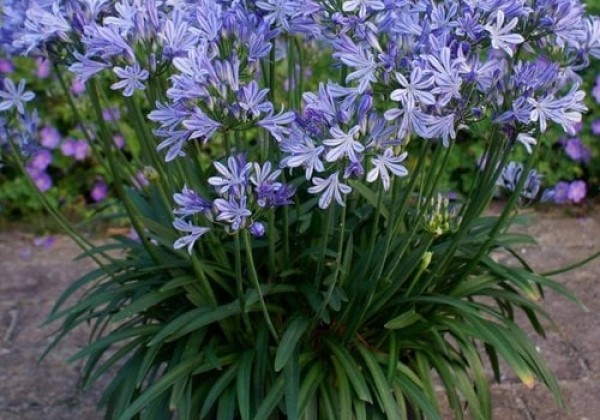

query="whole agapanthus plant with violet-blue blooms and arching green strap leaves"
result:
[3,0,600,419]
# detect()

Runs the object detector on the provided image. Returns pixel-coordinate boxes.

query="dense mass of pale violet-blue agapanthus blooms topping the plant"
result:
[5,0,600,244]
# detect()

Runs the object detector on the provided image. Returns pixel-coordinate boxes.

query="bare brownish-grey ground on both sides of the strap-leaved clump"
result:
[0,206,600,420]
